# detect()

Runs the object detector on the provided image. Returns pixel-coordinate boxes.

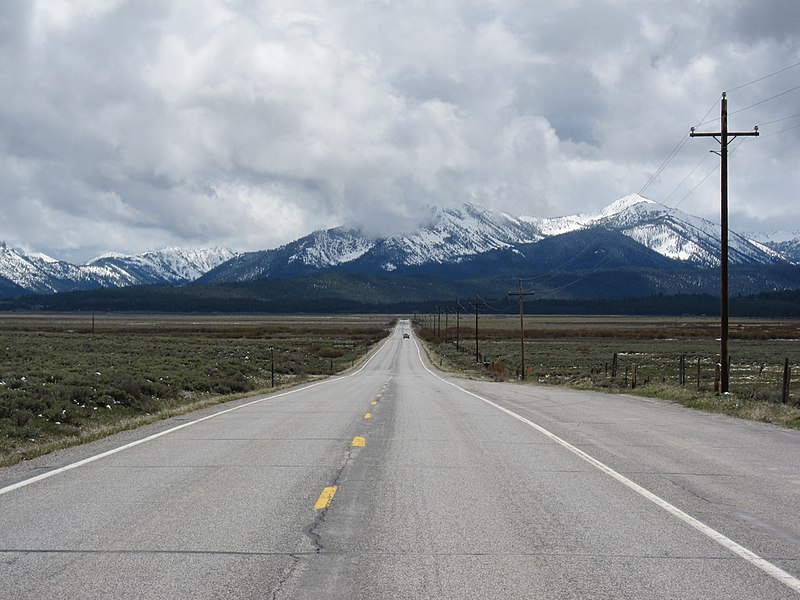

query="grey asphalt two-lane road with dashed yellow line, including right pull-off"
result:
[0,321,800,599]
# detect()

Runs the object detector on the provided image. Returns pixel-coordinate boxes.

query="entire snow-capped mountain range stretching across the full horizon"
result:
[0,194,800,298]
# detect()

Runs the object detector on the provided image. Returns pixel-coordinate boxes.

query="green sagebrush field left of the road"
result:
[0,314,392,465]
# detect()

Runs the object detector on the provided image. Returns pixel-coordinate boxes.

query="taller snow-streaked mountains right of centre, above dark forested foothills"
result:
[199,195,799,283]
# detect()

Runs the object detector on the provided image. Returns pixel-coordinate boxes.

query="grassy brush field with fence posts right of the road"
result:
[416,315,800,429]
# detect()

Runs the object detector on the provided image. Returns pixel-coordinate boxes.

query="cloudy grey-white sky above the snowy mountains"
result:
[0,0,800,262]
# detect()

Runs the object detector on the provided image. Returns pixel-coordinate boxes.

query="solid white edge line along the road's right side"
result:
[414,340,800,593]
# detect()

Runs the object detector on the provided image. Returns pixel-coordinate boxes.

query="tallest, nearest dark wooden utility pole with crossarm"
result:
[689,92,758,394]
